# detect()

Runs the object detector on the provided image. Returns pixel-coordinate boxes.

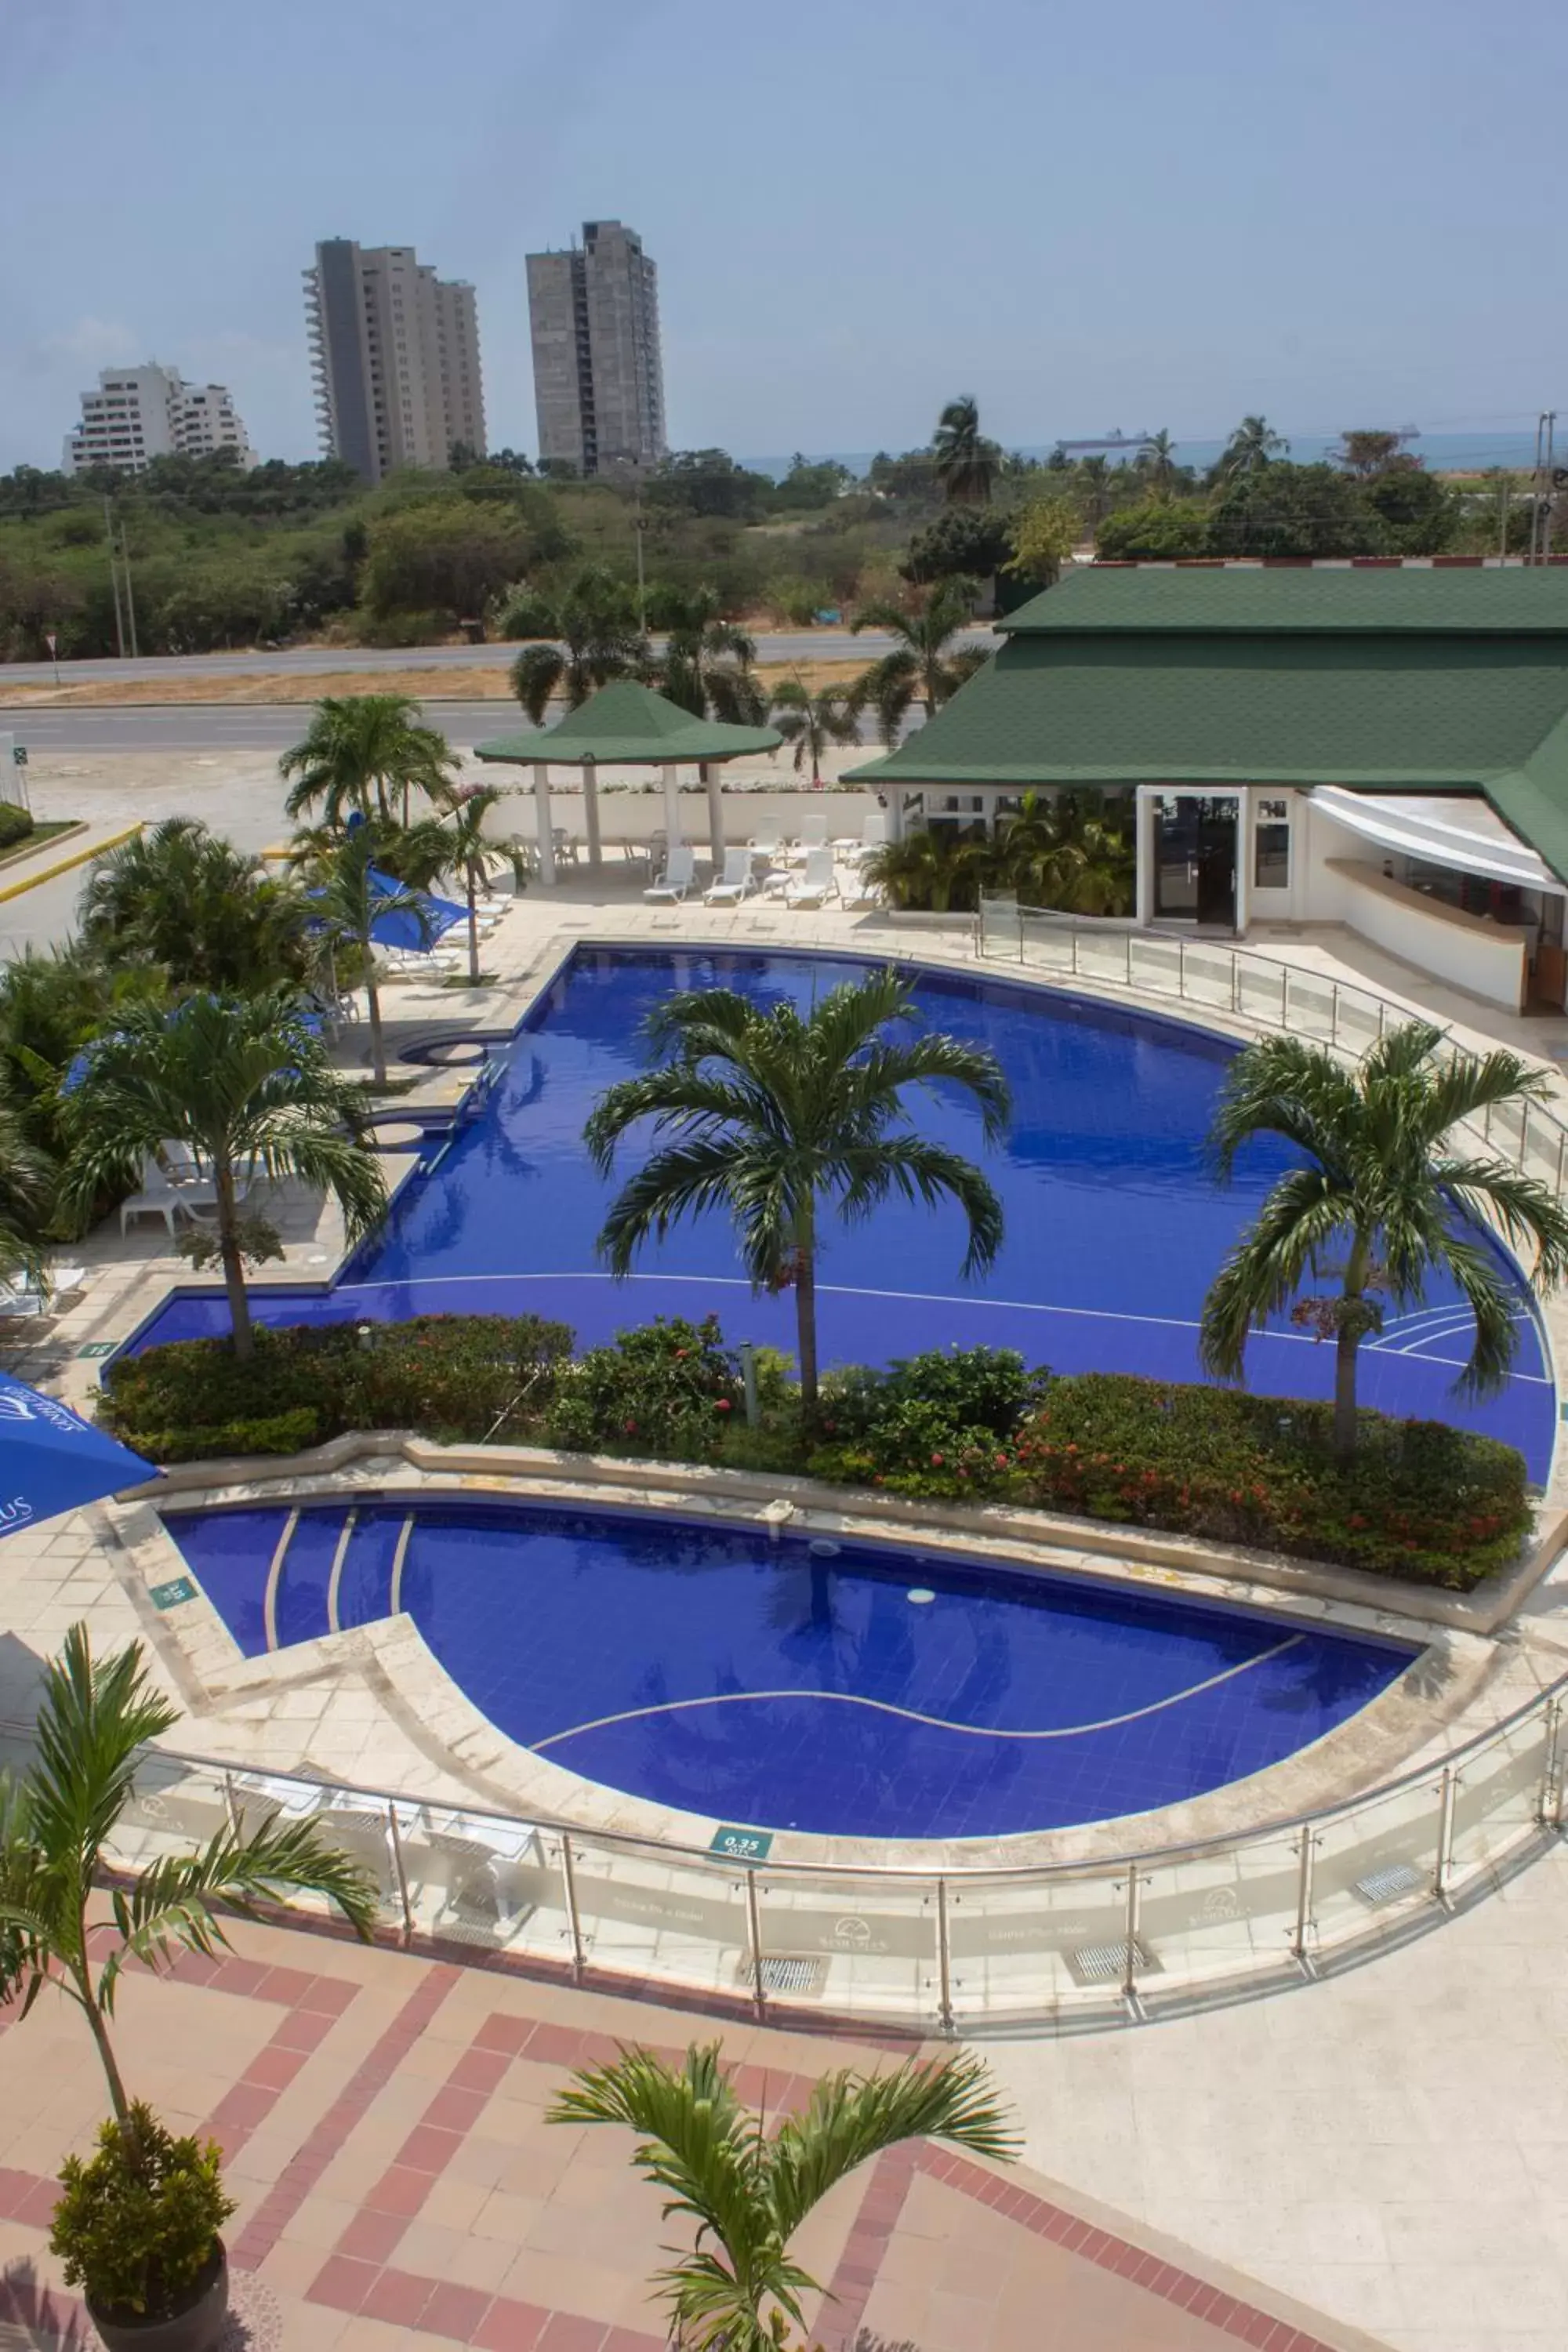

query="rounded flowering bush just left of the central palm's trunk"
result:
[548,1315,743,1463]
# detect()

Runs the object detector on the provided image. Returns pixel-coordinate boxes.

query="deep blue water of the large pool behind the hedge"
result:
[136,948,1556,1479]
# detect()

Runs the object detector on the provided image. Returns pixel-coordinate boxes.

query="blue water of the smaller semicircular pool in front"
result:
[167,1503,1410,1837]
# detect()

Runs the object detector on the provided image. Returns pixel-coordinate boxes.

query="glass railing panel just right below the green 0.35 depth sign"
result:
[748,1870,940,2020]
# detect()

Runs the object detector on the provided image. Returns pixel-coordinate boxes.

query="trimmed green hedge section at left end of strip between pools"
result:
[99,1315,572,1461]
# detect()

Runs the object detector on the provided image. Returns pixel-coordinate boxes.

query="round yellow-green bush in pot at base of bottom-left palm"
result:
[49,2100,235,2321]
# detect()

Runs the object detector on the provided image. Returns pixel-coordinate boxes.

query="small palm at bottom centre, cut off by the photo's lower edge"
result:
[546,2042,1018,2352]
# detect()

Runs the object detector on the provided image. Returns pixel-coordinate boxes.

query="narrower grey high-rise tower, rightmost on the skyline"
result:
[529,221,668,475]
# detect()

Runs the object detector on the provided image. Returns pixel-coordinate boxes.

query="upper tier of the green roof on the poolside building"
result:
[996,564,1568,637]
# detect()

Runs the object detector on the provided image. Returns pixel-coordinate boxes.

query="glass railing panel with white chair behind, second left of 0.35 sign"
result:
[402,1804,572,1959]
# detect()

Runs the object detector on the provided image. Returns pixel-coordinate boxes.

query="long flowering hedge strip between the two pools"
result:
[101,1315,1530,1590]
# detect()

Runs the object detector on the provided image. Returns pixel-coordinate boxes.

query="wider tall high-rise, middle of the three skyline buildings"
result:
[306,238,485,482]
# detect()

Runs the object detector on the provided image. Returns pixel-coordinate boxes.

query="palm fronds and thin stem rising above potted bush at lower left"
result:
[0,1625,376,2124]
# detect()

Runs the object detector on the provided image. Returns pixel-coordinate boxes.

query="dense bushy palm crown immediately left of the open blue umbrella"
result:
[80,816,308,988]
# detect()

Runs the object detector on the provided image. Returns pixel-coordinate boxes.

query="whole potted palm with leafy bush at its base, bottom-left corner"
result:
[0,1625,376,2352]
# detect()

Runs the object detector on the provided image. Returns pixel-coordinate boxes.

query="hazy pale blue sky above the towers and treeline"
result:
[0,0,1568,468]
